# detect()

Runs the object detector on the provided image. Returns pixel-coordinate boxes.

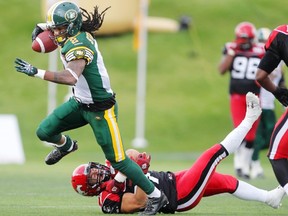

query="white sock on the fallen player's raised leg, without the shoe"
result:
[220,118,253,154]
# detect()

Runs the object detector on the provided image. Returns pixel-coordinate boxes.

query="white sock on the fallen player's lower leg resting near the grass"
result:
[232,180,268,203]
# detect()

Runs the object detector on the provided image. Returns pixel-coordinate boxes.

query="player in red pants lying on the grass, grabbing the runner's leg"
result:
[72,93,285,213]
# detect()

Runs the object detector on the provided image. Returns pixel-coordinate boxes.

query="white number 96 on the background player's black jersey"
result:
[231,56,260,80]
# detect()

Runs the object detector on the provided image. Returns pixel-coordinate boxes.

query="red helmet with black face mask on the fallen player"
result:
[71,162,110,196]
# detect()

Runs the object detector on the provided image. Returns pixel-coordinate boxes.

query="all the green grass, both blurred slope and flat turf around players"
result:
[0,0,288,216]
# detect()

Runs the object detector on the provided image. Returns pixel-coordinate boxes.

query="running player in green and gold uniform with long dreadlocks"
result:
[15,2,168,215]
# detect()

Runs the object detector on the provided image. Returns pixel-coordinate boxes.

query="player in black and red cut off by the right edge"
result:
[256,25,288,197]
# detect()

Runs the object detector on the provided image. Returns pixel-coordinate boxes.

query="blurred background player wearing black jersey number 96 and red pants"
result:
[218,22,265,178]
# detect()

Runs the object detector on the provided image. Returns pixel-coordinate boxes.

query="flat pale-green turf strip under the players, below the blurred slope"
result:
[0,152,288,216]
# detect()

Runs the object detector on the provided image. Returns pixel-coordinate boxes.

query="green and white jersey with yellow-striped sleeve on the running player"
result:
[61,32,113,104]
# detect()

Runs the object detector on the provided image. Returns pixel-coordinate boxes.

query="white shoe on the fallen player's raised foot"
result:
[245,92,262,123]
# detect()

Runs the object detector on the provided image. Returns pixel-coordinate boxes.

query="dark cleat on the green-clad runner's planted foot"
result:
[139,191,169,215]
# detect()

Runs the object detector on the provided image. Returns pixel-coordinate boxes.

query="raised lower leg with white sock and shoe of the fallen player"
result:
[220,92,262,154]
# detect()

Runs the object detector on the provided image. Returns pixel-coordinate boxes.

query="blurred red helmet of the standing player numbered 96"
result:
[235,22,256,50]
